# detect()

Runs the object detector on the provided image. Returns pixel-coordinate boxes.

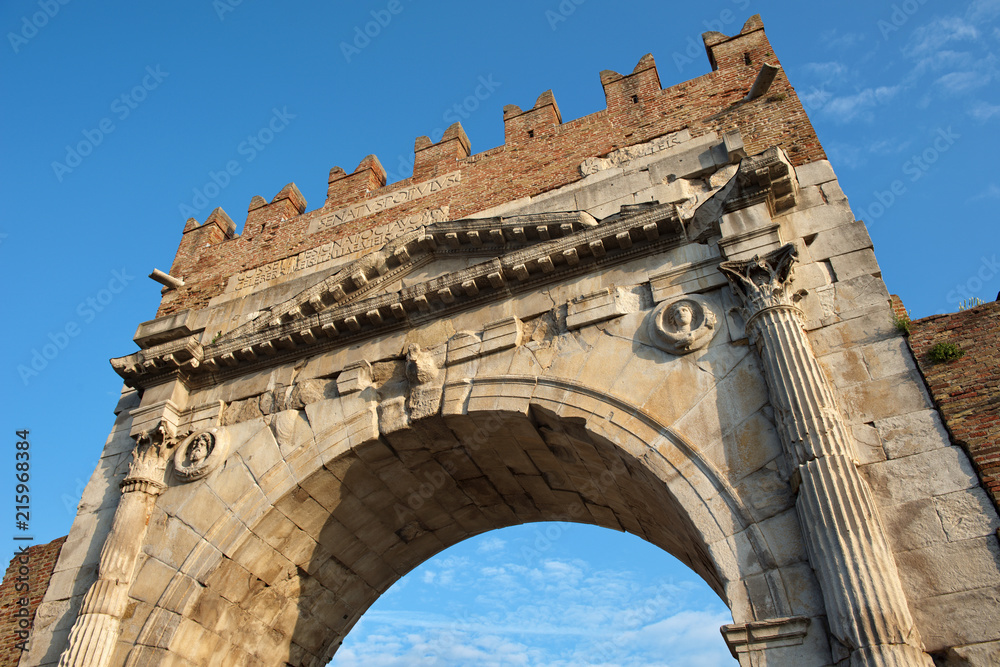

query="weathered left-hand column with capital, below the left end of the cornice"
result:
[59,422,173,667]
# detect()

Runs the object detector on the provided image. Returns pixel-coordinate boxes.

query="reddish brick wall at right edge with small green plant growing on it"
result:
[910,302,1000,509]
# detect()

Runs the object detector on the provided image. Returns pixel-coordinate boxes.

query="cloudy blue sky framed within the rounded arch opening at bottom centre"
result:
[330,523,735,667]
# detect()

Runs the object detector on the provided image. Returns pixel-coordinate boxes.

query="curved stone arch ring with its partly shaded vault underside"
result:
[119,377,807,665]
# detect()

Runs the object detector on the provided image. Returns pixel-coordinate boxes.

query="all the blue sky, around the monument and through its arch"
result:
[0,0,1000,665]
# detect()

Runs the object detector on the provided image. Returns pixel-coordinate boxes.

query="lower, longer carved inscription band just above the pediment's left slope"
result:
[227,206,448,292]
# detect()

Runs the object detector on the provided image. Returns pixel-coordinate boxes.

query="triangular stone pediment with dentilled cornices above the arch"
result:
[111,202,687,387]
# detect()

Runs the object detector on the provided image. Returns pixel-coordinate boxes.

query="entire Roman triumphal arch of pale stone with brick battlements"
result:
[27,17,1000,667]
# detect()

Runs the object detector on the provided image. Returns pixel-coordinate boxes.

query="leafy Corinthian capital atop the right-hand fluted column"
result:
[719,243,797,324]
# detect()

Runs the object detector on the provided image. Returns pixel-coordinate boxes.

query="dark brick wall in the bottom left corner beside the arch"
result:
[0,537,66,667]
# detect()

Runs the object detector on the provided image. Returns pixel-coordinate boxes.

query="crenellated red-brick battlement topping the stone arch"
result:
[157,16,825,317]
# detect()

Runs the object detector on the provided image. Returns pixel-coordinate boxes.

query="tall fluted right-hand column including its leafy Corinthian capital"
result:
[720,245,933,667]
